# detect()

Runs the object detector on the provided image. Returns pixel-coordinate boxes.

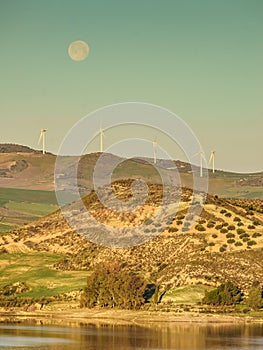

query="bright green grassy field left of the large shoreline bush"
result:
[0,253,87,298]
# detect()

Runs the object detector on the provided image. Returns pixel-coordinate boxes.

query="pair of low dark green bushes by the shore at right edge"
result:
[203,281,263,310]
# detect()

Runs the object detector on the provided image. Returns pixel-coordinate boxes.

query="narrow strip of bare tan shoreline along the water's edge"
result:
[0,309,263,326]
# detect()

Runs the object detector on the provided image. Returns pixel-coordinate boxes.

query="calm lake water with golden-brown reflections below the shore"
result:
[0,324,263,350]
